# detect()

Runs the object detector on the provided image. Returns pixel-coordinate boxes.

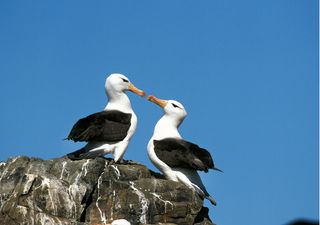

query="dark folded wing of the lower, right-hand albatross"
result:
[153,138,216,172]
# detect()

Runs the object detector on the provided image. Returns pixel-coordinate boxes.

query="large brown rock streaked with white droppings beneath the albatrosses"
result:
[0,156,212,225]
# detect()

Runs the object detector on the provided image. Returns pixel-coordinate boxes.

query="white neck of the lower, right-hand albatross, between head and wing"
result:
[152,114,182,140]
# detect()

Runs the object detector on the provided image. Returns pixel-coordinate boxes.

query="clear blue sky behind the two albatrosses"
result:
[0,0,319,225]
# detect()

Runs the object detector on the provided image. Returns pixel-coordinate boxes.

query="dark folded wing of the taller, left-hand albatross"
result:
[67,110,132,142]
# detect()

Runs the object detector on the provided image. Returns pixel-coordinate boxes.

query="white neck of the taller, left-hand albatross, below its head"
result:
[104,90,133,113]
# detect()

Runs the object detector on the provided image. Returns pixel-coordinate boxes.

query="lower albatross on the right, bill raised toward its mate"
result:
[147,96,221,205]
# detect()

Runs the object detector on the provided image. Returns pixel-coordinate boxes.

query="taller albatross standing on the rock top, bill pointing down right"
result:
[66,73,145,162]
